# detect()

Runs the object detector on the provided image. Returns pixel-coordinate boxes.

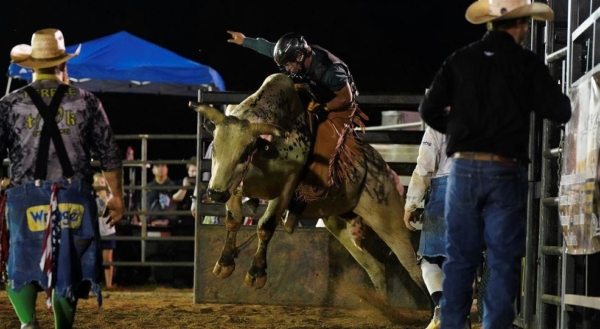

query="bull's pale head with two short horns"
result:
[189,102,287,202]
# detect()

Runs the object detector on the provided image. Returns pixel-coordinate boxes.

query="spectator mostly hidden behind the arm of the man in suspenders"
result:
[93,172,117,288]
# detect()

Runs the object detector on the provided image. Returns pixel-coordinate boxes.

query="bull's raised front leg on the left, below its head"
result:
[213,193,243,278]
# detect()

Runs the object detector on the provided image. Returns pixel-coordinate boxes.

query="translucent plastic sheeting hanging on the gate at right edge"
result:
[558,74,600,255]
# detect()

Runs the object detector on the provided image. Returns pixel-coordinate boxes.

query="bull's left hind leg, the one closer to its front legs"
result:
[323,216,388,299]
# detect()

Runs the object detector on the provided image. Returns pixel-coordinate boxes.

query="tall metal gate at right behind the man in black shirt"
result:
[514,0,600,329]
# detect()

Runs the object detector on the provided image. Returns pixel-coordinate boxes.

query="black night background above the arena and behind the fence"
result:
[0,0,485,177]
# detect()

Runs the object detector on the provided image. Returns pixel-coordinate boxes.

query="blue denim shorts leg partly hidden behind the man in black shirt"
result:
[417,176,448,257]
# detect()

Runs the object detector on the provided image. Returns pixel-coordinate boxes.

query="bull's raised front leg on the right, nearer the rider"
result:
[244,174,296,289]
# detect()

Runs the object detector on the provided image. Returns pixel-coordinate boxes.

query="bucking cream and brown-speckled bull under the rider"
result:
[190,73,426,297]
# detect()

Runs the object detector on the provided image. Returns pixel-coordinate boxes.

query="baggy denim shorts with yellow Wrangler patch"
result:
[6,181,102,304]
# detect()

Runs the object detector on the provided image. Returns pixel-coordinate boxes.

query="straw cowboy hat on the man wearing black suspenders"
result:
[10,29,81,69]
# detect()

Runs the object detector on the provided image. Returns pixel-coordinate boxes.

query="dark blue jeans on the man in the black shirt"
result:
[441,159,527,329]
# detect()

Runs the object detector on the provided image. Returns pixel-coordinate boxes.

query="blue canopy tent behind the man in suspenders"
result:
[7,31,225,97]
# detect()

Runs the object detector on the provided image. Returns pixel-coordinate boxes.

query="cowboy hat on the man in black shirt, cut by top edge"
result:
[465,0,554,24]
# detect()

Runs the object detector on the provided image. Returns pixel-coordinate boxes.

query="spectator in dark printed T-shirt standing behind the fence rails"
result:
[146,163,177,227]
